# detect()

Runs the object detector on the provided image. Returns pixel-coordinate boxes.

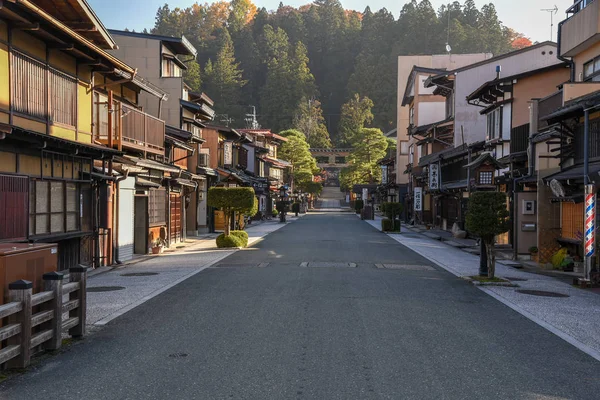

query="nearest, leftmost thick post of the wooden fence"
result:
[7,280,33,368]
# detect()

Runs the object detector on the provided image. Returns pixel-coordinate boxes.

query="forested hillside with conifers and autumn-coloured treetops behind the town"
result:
[150,0,530,144]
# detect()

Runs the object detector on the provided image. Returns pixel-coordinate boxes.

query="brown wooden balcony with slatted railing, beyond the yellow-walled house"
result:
[97,101,165,156]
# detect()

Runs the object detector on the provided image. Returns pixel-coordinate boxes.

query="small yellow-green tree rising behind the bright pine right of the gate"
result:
[337,93,373,147]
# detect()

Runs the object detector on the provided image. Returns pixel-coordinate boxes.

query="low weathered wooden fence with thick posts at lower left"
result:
[0,266,87,368]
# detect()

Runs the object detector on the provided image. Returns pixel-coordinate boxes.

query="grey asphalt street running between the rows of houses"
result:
[0,212,600,400]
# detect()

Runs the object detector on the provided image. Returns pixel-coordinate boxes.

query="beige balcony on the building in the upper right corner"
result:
[559,0,600,57]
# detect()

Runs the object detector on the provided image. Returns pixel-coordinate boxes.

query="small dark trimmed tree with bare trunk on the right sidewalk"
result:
[465,192,510,279]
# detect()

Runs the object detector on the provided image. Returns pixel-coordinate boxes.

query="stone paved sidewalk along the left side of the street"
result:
[87,216,300,328]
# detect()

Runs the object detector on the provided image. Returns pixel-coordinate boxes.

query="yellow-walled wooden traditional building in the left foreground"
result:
[0,0,164,269]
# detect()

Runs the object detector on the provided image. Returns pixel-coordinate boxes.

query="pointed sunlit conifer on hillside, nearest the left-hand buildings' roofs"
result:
[204,29,248,114]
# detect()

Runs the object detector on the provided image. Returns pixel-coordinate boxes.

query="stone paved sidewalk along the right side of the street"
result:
[365,218,600,361]
